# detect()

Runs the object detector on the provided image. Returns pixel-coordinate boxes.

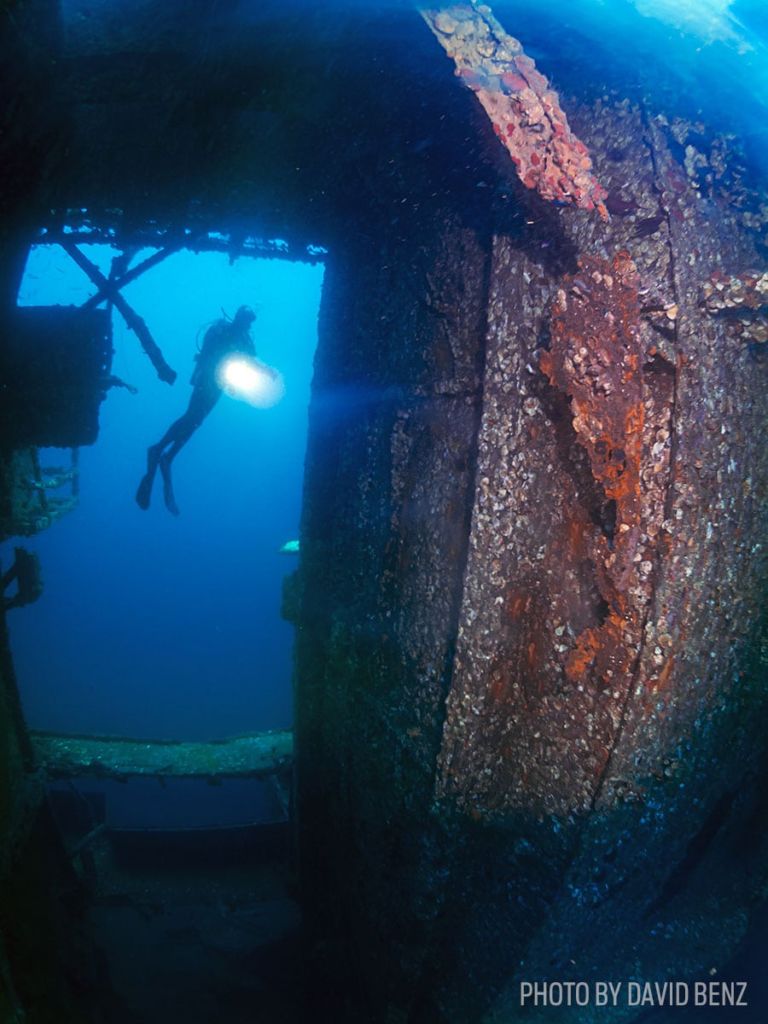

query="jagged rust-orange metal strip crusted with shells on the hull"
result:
[541,252,652,700]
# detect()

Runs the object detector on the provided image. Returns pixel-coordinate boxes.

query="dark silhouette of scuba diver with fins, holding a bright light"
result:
[136,306,256,515]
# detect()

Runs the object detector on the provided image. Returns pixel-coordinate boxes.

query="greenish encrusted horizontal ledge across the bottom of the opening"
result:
[31,731,293,781]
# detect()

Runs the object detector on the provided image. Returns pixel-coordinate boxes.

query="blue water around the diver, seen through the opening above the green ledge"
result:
[10,246,323,739]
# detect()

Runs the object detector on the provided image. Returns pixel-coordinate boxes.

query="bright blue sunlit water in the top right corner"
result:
[492,0,768,163]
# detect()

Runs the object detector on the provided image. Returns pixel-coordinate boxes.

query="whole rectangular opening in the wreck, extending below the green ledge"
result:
[3,234,325,830]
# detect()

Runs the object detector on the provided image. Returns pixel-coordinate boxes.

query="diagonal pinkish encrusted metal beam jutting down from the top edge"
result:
[422,4,607,218]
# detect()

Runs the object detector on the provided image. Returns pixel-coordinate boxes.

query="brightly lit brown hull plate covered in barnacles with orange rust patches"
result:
[437,245,675,815]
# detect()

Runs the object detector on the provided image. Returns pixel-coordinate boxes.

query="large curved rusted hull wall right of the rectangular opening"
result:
[297,103,768,1024]
